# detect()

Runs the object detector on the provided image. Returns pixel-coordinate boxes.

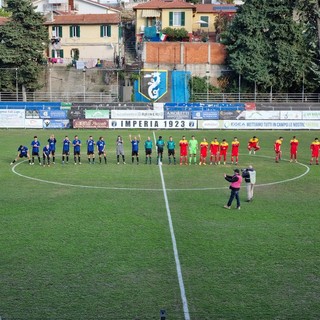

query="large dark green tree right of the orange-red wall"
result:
[222,0,312,92]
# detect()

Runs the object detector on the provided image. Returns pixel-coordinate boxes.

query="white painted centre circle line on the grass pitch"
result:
[11,155,310,192]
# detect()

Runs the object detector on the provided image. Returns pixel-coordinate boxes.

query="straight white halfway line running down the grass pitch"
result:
[153,131,190,320]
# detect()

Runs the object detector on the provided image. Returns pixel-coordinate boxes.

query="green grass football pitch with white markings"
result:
[0,129,320,320]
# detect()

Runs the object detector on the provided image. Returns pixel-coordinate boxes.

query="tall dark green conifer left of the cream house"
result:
[0,0,49,92]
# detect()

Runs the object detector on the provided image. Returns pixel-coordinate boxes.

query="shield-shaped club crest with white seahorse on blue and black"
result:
[139,69,168,102]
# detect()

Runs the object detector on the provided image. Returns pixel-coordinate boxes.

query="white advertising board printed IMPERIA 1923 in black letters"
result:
[109,119,197,129]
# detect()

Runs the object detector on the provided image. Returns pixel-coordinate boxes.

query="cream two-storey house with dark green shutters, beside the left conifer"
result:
[45,14,122,68]
